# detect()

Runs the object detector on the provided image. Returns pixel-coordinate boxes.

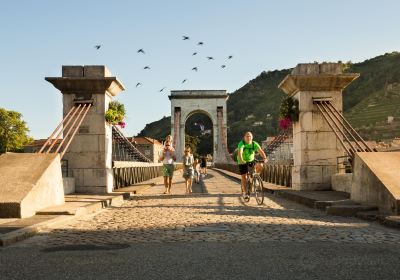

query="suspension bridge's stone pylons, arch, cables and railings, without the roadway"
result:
[0,63,400,223]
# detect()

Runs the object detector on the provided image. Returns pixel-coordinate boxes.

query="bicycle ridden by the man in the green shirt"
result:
[243,160,264,205]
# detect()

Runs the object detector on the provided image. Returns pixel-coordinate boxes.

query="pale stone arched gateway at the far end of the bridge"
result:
[169,90,229,163]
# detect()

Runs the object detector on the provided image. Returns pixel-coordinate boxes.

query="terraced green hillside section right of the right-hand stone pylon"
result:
[343,52,400,140]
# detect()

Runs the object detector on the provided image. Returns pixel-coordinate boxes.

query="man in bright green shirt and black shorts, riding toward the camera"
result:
[237,131,267,200]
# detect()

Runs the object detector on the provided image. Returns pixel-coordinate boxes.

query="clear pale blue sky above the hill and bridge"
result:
[0,0,400,138]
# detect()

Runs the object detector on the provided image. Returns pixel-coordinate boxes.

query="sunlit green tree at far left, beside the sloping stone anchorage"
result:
[0,108,32,153]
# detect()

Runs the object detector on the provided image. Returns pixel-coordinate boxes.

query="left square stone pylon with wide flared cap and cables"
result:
[46,65,125,193]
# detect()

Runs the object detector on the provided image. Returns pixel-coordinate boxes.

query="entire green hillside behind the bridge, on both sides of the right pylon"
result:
[136,52,400,150]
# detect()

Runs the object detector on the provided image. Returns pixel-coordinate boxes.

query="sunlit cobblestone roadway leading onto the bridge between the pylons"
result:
[14,170,400,246]
